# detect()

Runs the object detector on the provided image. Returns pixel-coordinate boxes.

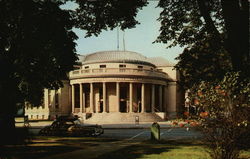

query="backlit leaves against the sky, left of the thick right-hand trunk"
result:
[156,0,223,47]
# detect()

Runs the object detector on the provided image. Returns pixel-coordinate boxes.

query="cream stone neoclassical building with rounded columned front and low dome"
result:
[25,51,184,122]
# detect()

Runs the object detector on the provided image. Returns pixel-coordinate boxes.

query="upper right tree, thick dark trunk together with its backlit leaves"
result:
[156,0,250,71]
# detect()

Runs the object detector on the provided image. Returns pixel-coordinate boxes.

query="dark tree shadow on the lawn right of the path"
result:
[96,140,201,159]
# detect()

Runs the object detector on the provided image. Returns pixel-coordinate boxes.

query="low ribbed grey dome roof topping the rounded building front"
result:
[81,51,155,66]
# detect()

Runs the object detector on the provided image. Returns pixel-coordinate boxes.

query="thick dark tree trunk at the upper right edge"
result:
[221,0,249,71]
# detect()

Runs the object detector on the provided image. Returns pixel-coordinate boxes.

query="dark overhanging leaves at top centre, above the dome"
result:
[74,0,147,36]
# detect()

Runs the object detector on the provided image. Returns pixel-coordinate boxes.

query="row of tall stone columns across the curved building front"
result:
[71,82,166,113]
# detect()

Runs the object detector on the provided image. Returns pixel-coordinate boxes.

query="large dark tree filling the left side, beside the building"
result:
[0,0,77,141]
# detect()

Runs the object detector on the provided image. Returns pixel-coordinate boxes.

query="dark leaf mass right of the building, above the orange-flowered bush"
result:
[175,39,232,89]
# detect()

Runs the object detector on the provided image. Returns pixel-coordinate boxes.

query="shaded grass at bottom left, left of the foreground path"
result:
[0,136,115,159]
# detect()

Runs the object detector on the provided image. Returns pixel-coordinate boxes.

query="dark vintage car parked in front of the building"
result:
[39,116,104,136]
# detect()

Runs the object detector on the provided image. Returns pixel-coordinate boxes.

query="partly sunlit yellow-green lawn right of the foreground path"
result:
[97,141,250,159]
